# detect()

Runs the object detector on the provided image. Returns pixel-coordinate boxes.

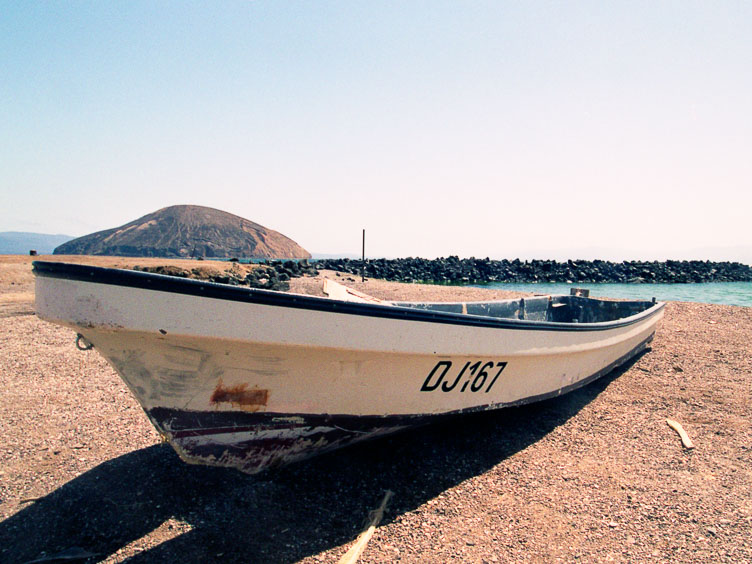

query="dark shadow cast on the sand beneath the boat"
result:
[0,359,648,562]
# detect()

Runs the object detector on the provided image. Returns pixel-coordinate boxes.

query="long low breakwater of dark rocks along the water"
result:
[315,256,752,284]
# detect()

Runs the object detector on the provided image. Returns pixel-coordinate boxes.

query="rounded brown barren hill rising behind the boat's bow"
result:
[54,206,311,258]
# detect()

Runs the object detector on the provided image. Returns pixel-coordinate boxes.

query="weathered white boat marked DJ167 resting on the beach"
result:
[33,261,665,473]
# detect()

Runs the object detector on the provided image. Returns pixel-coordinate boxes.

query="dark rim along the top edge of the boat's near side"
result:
[32,261,666,331]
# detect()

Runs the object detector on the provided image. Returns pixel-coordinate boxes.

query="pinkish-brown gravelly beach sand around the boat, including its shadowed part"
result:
[0,256,752,563]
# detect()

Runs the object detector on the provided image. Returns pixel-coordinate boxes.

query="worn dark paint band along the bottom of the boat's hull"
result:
[147,333,655,473]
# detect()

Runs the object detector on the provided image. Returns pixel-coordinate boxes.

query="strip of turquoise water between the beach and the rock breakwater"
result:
[479,282,752,306]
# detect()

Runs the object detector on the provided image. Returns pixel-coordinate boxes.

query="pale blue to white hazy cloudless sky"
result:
[0,0,752,262]
